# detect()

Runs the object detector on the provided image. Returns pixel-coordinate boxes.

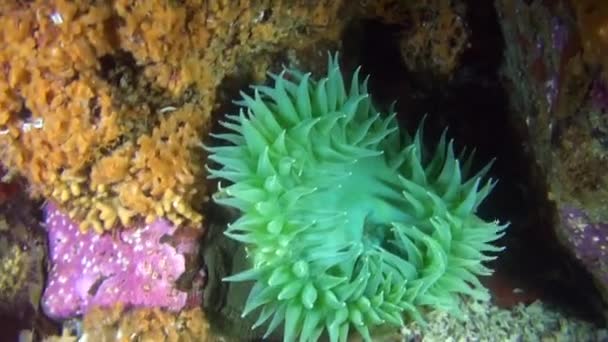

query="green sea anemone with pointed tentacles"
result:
[208,56,506,341]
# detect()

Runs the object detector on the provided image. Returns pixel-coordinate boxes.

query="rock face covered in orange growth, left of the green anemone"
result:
[0,0,346,233]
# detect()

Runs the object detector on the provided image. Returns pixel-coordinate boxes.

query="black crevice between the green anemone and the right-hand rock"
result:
[344,2,602,323]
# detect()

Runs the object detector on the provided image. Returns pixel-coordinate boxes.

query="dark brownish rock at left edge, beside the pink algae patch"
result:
[0,169,54,341]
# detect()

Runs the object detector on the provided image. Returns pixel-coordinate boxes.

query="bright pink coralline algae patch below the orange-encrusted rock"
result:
[42,204,202,320]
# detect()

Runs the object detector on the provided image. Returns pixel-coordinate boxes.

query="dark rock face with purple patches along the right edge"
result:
[495,0,608,299]
